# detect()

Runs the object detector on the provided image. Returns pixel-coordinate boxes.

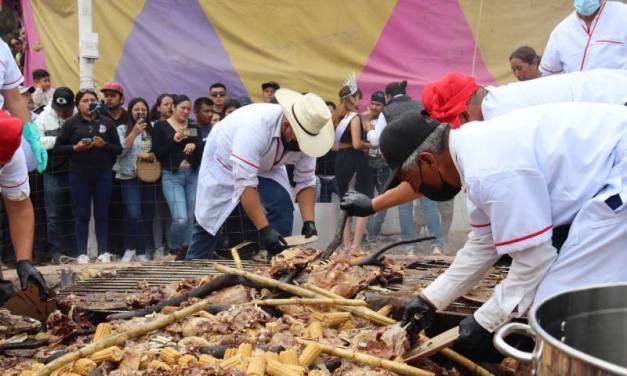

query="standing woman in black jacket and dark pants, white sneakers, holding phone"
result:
[53,89,122,264]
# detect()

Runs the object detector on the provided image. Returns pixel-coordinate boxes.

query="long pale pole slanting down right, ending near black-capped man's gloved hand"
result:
[213,264,396,325]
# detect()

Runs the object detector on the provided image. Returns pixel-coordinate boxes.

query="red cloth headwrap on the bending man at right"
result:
[422,73,478,128]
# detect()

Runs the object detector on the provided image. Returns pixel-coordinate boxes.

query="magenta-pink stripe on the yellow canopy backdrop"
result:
[358,0,495,100]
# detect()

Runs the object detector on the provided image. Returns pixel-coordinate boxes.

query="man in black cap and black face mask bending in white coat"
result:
[368,103,627,348]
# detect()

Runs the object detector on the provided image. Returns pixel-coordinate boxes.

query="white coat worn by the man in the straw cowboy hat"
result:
[195,103,316,235]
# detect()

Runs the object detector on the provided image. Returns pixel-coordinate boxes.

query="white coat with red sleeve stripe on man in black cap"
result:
[423,103,627,331]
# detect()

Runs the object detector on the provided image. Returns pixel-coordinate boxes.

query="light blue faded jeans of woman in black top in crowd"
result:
[161,168,198,251]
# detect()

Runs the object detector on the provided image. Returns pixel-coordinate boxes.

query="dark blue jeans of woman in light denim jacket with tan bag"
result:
[120,178,157,255]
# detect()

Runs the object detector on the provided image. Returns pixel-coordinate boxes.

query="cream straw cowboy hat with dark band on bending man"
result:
[275,89,335,158]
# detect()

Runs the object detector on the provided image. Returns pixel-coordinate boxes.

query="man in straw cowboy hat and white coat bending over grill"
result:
[186,89,334,260]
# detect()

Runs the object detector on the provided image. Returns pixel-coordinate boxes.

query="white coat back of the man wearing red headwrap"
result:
[481,69,627,120]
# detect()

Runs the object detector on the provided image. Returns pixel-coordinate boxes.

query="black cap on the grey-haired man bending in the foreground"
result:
[379,111,440,192]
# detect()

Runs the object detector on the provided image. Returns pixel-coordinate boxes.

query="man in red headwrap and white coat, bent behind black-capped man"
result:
[342,69,627,220]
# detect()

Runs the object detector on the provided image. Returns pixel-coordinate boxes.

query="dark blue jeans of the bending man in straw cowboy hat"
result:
[185,177,294,260]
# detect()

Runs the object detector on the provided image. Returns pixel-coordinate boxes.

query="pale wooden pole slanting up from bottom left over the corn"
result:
[35,299,218,376]
